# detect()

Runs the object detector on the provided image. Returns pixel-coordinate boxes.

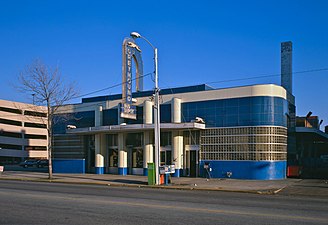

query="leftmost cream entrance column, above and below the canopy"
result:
[95,105,106,174]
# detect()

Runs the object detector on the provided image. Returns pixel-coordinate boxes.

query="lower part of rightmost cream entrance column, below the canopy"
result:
[172,131,184,177]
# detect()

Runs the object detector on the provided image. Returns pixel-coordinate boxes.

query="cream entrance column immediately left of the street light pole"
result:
[143,100,154,176]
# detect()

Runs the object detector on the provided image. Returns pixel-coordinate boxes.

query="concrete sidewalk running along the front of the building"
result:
[0,171,310,196]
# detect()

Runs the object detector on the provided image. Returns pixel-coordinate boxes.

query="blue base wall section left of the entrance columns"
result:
[52,159,85,173]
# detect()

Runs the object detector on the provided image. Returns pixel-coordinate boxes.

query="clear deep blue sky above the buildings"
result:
[0,0,328,129]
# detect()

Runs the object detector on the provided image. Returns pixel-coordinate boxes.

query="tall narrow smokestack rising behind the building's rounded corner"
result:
[281,41,293,94]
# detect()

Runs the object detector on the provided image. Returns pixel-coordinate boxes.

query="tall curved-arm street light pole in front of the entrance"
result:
[130,32,161,185]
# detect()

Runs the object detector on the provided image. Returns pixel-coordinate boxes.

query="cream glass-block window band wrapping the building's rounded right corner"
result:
[200,127,287,160]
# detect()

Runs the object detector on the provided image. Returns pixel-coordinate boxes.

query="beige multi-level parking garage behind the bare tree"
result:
[0,100,48,163]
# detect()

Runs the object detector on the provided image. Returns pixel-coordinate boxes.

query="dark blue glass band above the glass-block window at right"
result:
[181,96,288,127]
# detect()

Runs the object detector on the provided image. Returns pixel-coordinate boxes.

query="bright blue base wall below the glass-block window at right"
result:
[199,160,287,180]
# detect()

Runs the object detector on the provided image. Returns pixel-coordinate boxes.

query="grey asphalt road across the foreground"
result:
[0,180,328,225]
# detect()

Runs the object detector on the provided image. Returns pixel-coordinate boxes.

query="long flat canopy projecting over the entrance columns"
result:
[66,122,205,134]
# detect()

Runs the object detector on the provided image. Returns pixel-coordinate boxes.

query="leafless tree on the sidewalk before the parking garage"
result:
[19,59,77,179]
